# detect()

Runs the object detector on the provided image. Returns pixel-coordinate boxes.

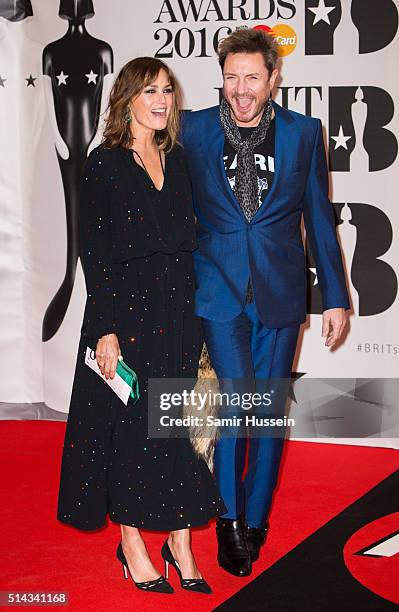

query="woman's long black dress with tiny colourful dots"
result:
[58,146,226,531]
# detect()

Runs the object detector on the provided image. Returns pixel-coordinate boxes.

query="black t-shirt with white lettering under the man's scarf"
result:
[223,119,276,206]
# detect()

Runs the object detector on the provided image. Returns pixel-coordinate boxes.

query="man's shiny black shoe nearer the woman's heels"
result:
[216,518,252,576]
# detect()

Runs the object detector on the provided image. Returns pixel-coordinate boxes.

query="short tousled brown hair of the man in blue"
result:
[218,29,278,75]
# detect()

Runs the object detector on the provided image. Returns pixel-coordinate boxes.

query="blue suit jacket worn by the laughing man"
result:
[182,103,349,328]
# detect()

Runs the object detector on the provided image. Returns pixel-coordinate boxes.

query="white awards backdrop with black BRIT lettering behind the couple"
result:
[0,0,399,445]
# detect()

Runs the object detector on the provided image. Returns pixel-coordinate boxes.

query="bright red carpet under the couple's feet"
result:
[0,421,399,612]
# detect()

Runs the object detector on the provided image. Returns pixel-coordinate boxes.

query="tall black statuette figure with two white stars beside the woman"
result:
[42,0,113,342]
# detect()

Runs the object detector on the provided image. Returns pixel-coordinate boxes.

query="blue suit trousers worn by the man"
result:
[202,302,299,527]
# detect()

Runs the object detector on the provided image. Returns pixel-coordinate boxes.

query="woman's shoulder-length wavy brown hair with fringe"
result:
[103,57,182,152]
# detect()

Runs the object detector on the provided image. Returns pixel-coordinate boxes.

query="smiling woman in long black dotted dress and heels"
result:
[58,58,226,592]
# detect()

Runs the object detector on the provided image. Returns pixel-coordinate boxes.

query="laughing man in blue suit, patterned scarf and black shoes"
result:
[182,30,349,576]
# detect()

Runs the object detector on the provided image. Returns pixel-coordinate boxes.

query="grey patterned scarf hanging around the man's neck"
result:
[220,98,273,221]
